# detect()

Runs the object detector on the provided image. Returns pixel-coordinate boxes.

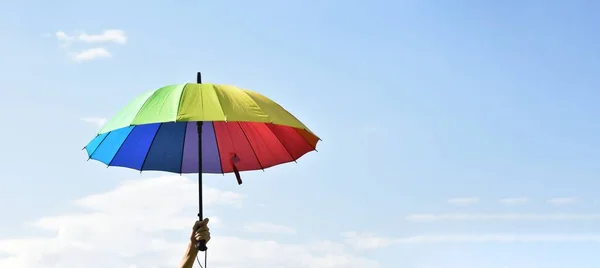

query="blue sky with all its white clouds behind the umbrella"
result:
[0,0,600,268]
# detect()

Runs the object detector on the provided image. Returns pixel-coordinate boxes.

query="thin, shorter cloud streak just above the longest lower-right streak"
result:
[406,213,600,222]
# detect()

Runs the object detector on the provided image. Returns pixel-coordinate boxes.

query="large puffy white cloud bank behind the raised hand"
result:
[0,175,379,268]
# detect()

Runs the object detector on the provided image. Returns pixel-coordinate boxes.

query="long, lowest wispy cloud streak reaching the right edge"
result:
[343,232,600,250]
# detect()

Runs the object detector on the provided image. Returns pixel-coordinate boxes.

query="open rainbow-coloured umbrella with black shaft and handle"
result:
[84,73,320,251]
